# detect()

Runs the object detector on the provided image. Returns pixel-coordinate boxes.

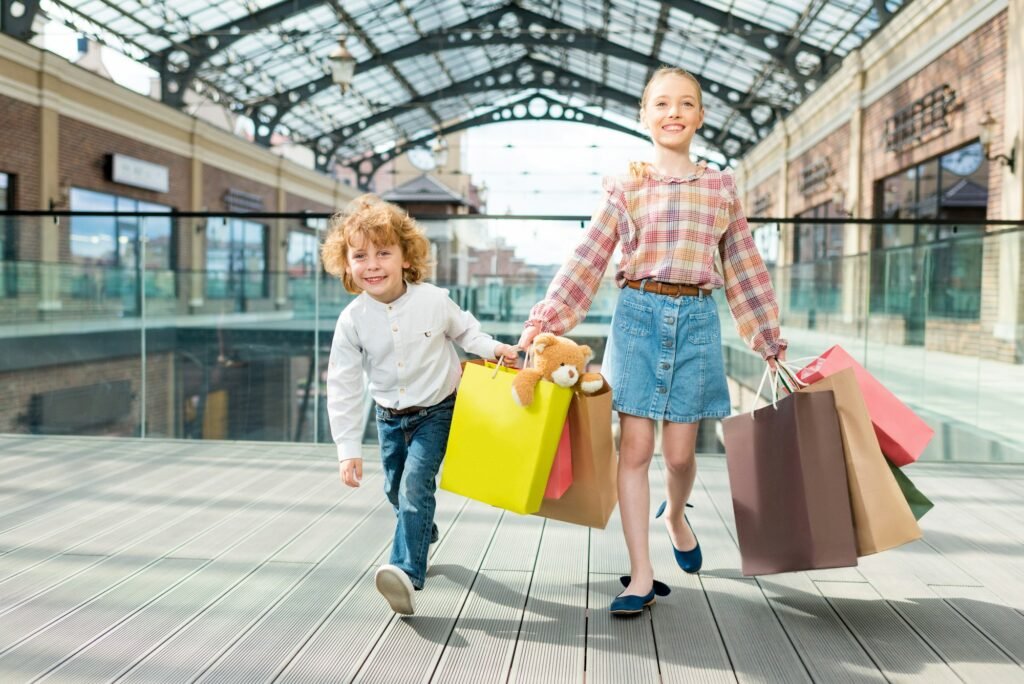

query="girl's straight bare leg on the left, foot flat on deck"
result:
[618,413,654,596]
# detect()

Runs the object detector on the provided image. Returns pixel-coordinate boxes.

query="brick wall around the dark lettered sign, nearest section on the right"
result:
[861,12,1007,218]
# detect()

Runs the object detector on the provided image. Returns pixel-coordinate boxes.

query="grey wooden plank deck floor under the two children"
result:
[0,436,1024,684]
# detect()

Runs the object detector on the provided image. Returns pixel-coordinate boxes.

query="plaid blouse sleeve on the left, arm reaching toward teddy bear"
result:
[526,177,625,335]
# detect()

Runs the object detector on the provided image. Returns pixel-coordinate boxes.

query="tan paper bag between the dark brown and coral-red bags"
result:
[799,369,921,556]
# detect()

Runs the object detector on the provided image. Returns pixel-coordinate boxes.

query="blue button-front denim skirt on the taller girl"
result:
[603,288,731,423]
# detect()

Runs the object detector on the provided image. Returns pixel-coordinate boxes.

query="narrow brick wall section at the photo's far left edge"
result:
[0,95,42,261]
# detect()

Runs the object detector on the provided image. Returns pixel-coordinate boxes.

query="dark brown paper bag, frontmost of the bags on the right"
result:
[722,391,857,575]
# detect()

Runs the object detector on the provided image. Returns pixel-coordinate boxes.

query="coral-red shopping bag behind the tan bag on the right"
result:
[797,344,935,466]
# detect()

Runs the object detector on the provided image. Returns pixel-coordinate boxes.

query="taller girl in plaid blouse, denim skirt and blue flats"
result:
[519,67,786,615]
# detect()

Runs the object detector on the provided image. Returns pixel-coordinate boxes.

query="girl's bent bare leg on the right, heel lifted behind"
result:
[659,421,699,551]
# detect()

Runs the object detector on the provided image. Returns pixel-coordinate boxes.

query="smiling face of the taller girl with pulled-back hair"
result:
[641,74,703,152]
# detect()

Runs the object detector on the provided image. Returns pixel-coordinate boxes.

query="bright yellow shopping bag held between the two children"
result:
[441,360,572,515]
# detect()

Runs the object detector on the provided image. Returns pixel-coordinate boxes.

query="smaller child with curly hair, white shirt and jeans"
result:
[321,195,516,615]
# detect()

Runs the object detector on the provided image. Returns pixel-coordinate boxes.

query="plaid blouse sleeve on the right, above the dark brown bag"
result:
[719,174,787,358]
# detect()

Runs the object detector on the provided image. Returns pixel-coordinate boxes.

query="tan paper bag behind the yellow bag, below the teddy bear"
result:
[535,383,618,529]
